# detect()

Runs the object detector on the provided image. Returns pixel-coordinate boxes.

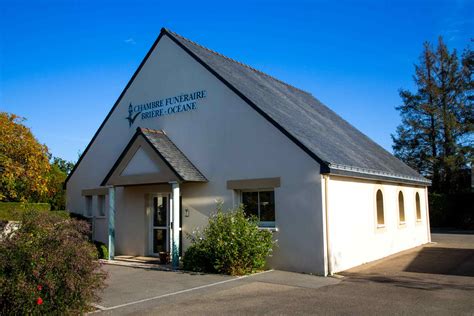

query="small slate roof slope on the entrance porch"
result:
[137,127,207,182]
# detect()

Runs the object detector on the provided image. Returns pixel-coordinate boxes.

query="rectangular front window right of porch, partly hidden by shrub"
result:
[242,190,275,227]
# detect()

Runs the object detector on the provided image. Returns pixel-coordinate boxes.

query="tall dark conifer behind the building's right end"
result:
[392,37,474,192]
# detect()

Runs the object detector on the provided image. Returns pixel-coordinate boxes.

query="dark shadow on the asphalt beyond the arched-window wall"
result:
[404,247,474,277]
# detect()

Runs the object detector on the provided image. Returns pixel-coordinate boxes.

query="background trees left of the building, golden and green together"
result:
[0,112,74,210]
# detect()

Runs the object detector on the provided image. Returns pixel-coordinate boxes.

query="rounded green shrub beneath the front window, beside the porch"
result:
[183,205,273,275]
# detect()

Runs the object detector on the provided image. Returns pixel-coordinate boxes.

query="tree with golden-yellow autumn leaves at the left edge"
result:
[0,112,51,201]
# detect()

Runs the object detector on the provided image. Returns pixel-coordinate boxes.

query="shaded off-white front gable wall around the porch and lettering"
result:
[67,36,324,274]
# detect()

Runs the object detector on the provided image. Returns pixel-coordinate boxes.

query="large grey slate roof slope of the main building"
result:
[166,29,430,185]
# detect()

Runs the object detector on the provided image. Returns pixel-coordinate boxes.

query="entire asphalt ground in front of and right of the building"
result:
[92,234,474,315]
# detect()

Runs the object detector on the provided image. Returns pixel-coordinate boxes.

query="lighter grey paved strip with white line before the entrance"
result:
[92,265,340,314]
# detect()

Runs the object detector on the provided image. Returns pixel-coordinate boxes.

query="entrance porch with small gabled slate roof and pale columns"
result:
[101,127,207,267]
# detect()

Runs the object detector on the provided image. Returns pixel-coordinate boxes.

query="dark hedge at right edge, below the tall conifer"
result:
[428,192,474,230]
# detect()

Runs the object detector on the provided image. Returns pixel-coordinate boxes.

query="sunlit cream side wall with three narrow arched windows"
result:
[323,176,430,272]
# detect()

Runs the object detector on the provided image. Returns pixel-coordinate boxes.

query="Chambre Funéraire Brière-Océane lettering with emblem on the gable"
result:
[125,90,207,127]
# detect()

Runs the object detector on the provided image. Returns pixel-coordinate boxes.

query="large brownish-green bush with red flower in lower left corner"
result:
[0,211,106,315]
